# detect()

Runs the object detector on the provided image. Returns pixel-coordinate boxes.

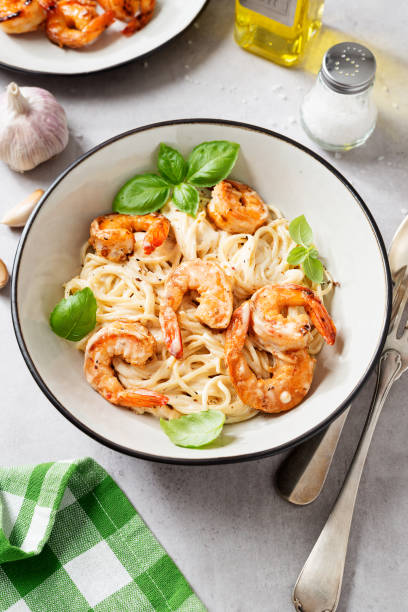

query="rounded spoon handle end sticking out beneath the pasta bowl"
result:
[275,406,350,506]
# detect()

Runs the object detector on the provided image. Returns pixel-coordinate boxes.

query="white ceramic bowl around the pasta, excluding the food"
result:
[12,119,391,464]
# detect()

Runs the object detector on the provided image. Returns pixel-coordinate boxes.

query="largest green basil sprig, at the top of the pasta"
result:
[113,140,239,217]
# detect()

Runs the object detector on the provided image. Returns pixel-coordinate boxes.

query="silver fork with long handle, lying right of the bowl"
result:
[292,268,408,612]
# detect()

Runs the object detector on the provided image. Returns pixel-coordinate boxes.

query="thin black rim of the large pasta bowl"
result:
[11,119,392,465]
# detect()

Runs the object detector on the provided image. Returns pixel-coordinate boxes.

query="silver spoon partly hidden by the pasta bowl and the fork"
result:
[275,217,408,506]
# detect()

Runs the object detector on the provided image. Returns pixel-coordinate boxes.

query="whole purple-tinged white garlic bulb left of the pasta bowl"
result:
[0,83,68,172]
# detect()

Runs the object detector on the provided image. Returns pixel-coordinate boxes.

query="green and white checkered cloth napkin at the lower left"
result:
[0,459,205,612]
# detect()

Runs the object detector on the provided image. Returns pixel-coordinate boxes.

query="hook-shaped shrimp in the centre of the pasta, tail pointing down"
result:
[160,259,232,359]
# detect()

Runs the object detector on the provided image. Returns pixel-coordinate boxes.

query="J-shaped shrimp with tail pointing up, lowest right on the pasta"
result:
[225,301,316,412]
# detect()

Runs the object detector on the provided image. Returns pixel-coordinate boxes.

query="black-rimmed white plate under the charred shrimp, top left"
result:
[0,0,207,75]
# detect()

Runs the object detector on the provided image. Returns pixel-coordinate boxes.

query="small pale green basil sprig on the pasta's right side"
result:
[287,215,324,283]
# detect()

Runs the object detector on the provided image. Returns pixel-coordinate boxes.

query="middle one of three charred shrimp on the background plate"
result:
[45,0,115,49]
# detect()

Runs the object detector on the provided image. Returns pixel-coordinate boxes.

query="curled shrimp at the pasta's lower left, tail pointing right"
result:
[84,321,178,418]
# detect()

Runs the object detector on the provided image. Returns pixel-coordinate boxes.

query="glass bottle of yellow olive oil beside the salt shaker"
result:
[235,0,324,66]
